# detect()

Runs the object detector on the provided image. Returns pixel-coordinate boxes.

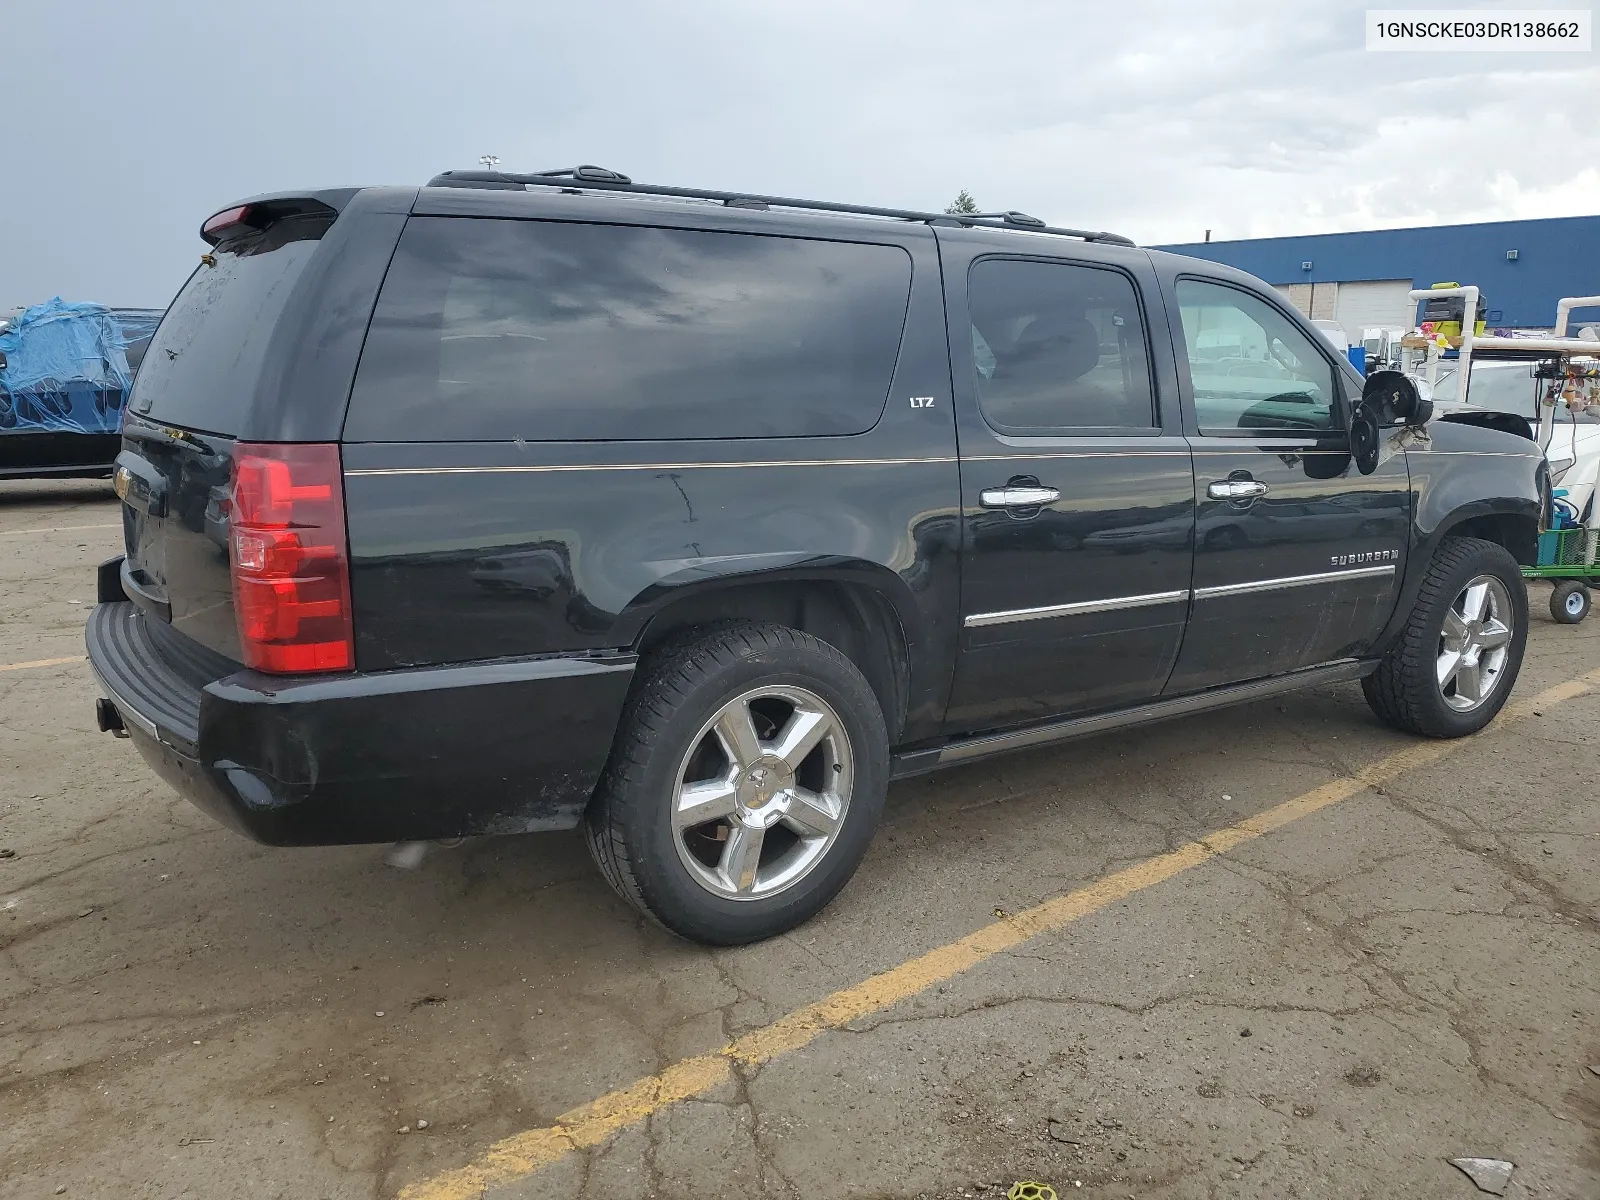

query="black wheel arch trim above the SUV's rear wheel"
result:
[634,574,914,742]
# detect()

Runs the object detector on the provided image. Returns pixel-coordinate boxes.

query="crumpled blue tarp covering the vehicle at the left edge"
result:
[0,296,158,434]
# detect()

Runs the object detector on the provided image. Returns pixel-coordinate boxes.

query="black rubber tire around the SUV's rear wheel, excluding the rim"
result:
[584,622,890,946]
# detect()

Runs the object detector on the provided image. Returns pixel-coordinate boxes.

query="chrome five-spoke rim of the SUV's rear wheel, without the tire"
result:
[672,685,854,901]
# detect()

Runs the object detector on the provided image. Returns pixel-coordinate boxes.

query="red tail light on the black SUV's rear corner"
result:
[227,442,355,674]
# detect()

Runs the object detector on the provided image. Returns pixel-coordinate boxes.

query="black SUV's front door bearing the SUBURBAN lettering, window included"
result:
[1166,277,1411,694]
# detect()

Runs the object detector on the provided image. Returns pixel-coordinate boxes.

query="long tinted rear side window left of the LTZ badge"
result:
[344,218,910,442]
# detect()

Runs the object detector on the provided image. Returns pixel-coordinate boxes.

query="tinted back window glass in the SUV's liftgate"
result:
[128,216,331,437]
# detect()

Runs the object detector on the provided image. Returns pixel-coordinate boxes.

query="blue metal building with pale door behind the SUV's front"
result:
[1158,216,1600,341]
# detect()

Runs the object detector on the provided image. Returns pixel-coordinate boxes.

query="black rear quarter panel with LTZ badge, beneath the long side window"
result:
[344,212,960,738]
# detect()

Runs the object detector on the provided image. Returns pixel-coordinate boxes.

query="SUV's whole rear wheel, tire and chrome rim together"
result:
[586,622,888,946]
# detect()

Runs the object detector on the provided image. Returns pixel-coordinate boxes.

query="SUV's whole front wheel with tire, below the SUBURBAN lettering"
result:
[1362,538,1528,738]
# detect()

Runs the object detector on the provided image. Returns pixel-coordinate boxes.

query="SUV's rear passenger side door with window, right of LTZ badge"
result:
[942,245,1194,733]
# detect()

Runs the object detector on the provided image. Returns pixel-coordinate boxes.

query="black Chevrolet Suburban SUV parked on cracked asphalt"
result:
[88,168,1542,942]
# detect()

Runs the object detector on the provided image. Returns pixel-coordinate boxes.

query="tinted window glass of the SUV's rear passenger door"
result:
[968,259,1155,434]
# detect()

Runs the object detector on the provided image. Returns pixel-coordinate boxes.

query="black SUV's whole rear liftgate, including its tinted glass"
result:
[115,210,344,659]
